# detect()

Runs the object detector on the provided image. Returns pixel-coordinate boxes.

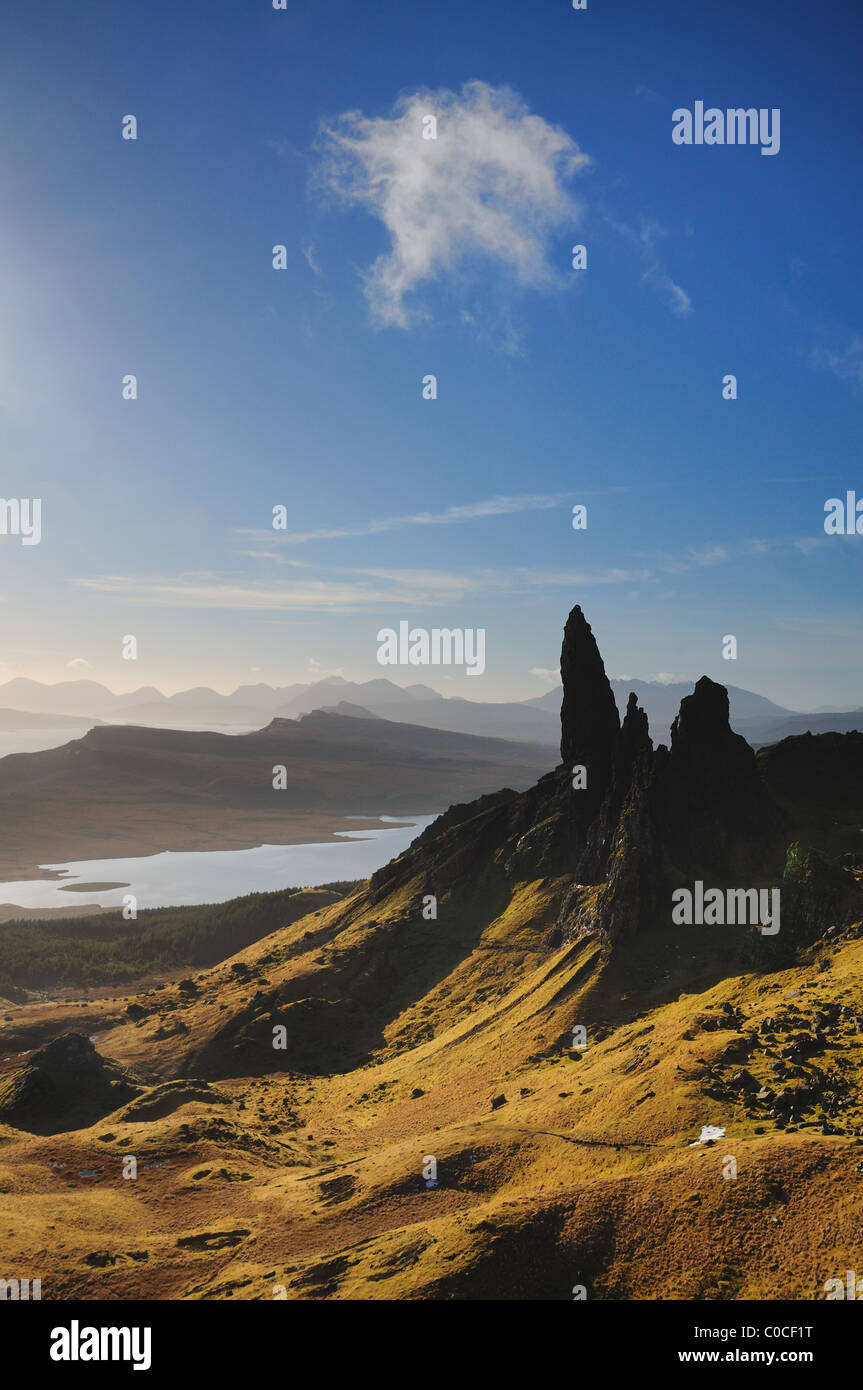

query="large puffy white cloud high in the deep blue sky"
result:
[321,82,589,328]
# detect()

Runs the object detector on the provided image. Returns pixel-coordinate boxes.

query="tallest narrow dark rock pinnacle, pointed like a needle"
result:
[560,605,620,805]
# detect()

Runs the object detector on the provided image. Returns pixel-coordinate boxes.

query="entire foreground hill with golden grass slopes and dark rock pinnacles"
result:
[0,609,863,1301]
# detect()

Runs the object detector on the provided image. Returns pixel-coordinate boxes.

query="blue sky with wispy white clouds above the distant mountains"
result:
[0,0,863,709]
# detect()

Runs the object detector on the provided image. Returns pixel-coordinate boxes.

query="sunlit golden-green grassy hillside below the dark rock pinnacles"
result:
[0,861,863,1301]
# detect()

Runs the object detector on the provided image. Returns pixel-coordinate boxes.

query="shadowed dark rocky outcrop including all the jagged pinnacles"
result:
[355,607,863,959]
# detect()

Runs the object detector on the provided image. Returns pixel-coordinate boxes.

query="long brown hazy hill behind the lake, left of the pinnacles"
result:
[0,712,552,878]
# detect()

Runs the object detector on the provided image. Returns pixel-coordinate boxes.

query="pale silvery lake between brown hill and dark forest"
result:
[0,816,436,910]
